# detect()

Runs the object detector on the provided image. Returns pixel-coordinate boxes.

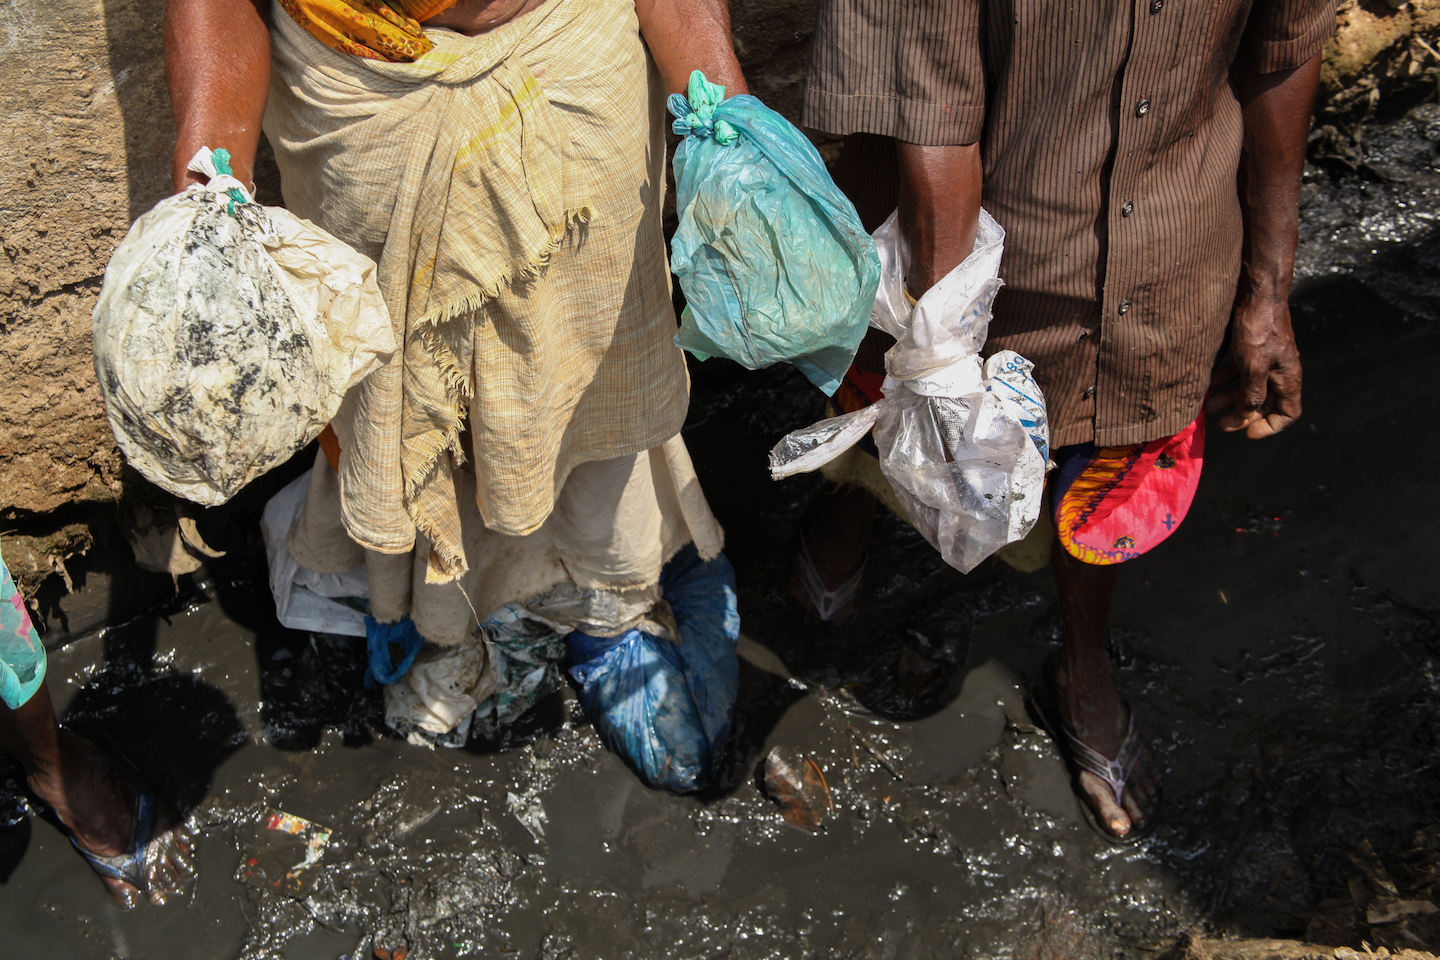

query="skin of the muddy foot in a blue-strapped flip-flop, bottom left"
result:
[29,730,194,910]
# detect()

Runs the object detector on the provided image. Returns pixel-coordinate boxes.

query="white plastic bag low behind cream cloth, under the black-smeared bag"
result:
[261,468,370,638]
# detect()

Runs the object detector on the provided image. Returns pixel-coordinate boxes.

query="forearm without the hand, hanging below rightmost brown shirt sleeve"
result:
[1234,55,1320,301]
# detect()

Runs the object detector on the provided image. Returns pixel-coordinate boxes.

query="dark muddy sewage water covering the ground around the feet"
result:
[8,107,1440,960]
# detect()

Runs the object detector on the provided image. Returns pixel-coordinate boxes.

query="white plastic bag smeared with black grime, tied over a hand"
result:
[94,148,395,505]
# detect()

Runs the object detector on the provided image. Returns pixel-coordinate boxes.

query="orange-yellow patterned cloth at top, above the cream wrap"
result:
[279,0,455,63]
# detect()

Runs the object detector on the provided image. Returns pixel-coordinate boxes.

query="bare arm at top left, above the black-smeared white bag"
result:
[166,0,271,190]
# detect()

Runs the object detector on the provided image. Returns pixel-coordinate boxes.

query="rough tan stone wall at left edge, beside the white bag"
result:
[0,0,173,517]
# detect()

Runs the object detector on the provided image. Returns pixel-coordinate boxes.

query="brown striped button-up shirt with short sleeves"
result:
[804,0,1335,446]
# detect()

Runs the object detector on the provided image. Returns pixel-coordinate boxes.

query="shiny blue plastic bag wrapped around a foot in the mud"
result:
[569,544,740,793]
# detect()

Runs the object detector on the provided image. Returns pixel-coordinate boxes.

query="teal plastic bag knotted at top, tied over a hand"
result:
[670,71,880,396]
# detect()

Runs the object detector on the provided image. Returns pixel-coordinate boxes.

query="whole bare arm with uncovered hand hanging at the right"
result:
[1208,53,1320,439]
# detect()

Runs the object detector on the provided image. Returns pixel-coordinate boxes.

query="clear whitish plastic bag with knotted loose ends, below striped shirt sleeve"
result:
[770,210,1048,573]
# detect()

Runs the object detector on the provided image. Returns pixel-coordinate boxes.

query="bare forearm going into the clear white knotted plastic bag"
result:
[897,142,981,298]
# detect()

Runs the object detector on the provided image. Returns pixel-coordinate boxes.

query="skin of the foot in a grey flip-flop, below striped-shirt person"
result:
[1053,658,1161,839]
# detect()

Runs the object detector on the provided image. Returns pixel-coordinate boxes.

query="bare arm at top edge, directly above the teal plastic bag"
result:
[635,0,750,96]
